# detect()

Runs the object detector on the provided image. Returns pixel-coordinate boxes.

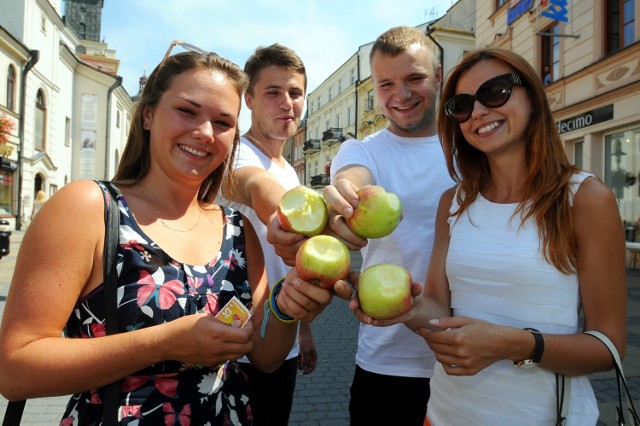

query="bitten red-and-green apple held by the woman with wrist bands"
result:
[296,235,351,289]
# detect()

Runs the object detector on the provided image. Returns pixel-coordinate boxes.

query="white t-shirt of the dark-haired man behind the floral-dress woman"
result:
[216,137,300,361]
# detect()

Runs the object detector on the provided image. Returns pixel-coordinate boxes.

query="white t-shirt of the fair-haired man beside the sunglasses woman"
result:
[331,129,453,377]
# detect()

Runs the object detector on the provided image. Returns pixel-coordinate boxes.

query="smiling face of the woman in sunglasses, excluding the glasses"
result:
[455,59,532,155]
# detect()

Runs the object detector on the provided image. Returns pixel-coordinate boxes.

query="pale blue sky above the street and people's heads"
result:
[101,0,454,129]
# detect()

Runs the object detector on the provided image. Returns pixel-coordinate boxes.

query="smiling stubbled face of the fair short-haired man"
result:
[371,43,441,137]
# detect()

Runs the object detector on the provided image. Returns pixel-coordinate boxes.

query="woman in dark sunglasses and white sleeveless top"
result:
[359,48,626,425]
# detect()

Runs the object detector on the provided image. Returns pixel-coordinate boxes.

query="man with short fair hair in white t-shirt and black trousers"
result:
[324,27,453,426]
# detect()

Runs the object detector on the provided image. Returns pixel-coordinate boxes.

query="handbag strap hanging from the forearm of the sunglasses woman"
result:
[556,330,640,426]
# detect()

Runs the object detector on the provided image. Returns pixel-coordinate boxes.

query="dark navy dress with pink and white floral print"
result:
[61,182,252,425]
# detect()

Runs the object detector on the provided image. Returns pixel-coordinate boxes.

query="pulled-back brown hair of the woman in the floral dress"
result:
[113,52,246,204]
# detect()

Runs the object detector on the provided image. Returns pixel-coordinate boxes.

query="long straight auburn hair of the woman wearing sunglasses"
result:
[438,48,578,273]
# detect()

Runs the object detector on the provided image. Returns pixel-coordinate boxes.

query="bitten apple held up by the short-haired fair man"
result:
[347,185,402,238]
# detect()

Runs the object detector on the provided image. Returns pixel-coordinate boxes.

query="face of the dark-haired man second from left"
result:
[245,65,305,140]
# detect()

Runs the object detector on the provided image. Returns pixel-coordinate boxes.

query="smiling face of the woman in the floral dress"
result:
[143,69,240,182]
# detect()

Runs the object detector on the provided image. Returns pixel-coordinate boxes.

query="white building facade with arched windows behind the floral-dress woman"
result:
[0,0,133,229]
